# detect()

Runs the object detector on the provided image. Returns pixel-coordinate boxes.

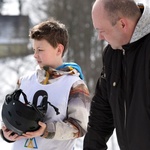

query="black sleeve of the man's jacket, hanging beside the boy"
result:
[84,48,114,150]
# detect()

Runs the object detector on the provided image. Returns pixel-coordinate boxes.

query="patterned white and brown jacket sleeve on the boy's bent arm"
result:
[47,80,90,140]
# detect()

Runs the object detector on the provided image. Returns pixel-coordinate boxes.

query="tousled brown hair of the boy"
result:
[29,18,69,56]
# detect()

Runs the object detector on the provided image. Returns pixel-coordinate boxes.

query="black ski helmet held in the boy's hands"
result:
[2,89,48,135]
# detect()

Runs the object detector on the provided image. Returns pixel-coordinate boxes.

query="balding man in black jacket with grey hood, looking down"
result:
[84,0,150,150]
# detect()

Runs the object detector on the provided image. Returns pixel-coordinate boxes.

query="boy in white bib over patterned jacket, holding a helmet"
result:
[2,19,90,150]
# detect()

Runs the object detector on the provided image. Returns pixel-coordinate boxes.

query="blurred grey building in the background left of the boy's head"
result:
[0,15,31,58]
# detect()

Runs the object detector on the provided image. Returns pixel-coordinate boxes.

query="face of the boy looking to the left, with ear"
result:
[33,39,62,68]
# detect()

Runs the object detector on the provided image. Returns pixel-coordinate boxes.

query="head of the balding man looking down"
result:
[92,0,141,49]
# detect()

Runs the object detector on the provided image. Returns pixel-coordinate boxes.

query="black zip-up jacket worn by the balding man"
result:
[84,34,150,150]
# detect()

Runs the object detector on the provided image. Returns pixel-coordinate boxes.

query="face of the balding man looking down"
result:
[92,2,124,49]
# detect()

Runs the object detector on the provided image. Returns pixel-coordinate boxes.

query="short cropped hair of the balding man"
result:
[103,0,141,25]
